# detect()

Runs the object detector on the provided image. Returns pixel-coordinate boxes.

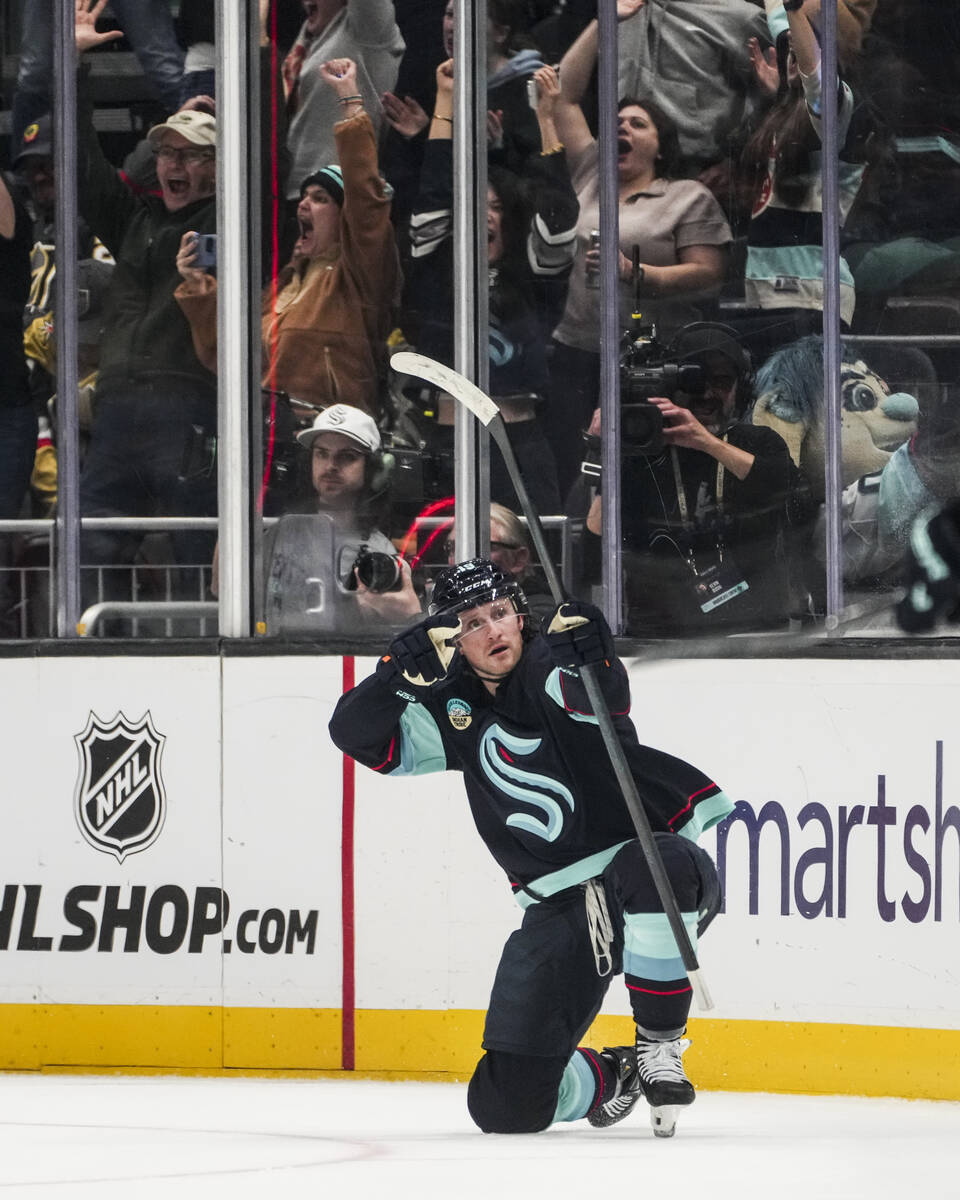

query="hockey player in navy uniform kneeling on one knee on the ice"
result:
[330,558,732,1135]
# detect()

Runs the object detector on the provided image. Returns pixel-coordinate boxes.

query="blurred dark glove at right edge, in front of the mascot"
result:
[896,500,960,634]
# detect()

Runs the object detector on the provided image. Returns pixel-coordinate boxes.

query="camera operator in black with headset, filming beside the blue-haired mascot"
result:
[587,323,812,637]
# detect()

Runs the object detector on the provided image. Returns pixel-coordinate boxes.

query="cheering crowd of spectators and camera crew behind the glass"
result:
[0,0,960,636]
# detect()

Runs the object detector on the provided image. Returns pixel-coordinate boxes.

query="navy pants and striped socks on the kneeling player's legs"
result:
[467,834,720,1133]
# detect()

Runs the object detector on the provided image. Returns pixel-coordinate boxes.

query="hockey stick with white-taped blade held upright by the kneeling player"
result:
[390,350,713,1012]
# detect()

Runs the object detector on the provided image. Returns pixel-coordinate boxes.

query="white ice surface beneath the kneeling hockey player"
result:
[0,1074,960,1200]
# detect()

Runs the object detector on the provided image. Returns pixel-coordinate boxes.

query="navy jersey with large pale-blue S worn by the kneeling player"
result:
[330,637,733,904]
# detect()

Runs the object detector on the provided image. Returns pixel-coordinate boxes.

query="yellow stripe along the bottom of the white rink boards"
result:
[0,1004,960,1100]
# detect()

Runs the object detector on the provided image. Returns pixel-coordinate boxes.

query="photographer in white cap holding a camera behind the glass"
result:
[263,404,421,634]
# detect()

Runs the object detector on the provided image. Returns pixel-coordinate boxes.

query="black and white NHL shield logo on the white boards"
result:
[73,712,167,863]
